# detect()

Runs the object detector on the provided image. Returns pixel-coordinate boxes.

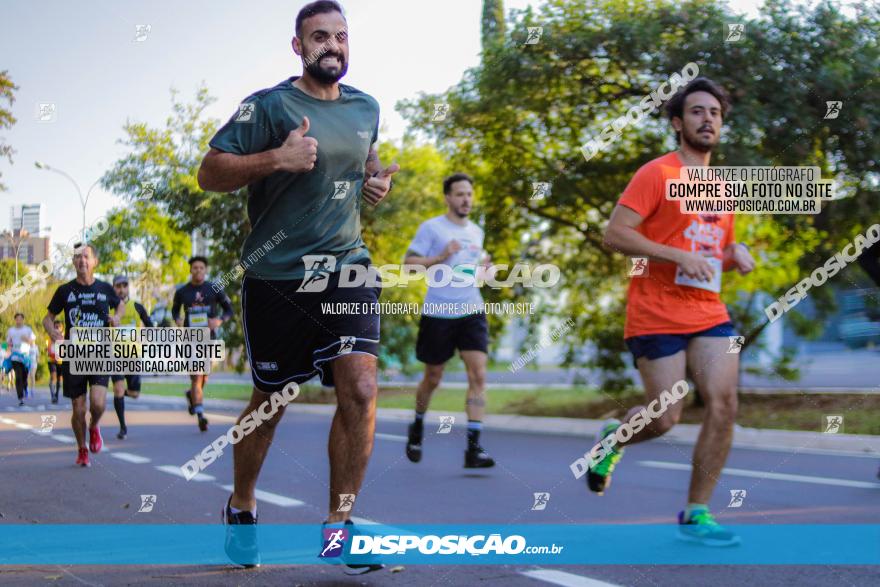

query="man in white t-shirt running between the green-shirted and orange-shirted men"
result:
[404,173,495,468]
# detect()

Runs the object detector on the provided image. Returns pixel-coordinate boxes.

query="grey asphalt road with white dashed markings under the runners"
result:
[0,392,880,587]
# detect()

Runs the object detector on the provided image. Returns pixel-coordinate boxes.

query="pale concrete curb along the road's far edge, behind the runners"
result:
[139,393,880,457]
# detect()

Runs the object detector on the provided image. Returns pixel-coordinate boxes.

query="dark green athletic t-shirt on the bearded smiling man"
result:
[210,77,379,279]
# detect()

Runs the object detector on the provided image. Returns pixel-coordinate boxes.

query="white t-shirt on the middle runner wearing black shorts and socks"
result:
[408,215,483,318]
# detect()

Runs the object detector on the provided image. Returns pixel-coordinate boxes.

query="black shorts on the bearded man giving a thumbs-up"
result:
[241,273,382,393]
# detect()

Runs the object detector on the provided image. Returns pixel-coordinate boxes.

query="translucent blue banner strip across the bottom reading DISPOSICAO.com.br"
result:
[0,524,880,565]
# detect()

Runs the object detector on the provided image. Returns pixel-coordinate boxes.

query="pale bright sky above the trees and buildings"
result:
[0,0,776,242]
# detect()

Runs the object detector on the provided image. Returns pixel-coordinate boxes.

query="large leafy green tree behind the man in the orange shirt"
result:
[399,0,880,396]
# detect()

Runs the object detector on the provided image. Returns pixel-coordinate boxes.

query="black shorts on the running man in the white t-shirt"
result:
[416,313,489,365]
